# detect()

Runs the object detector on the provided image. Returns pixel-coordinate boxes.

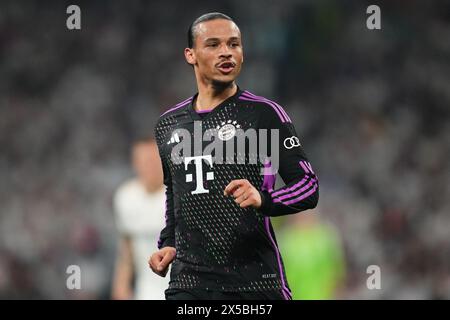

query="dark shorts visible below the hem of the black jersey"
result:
[165,289,287,300]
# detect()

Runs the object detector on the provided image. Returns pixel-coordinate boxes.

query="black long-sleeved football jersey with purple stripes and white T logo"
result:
[155,88,319,299]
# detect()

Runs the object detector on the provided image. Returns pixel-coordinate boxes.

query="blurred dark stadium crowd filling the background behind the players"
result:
[0,0,450,299]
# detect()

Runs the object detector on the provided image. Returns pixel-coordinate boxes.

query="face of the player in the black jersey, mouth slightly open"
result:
[185,19,243,83]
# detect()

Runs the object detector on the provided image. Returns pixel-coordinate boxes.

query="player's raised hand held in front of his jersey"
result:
[224,179,262,209]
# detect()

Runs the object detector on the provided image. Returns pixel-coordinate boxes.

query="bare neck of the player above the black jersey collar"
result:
[194,82,237,111]
